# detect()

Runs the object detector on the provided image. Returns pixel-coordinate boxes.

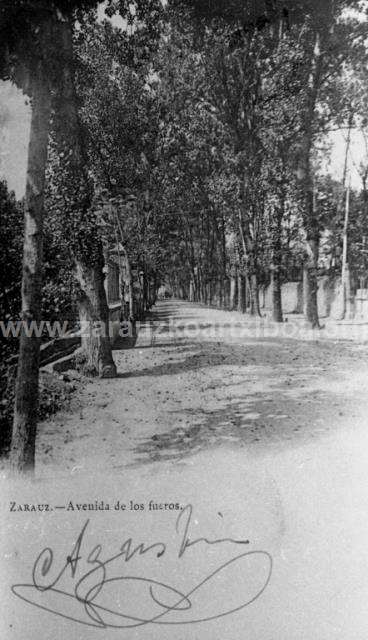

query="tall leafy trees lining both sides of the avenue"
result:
[0,0,368,470]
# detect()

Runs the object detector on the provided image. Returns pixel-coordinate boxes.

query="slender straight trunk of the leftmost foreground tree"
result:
[10,65,51,472]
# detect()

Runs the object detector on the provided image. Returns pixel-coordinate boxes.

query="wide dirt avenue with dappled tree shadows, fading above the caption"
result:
[37,301,368,474]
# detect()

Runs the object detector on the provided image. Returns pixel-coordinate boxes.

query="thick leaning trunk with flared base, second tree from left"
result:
[55,20,115,377]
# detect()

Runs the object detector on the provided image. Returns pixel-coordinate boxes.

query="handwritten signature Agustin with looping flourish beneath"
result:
[11,505,272,629]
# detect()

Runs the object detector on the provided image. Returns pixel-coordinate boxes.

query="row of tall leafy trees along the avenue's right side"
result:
[155,2,367,320]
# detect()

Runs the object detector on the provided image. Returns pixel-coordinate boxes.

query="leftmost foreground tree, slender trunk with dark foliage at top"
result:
[0,0,107,471]
